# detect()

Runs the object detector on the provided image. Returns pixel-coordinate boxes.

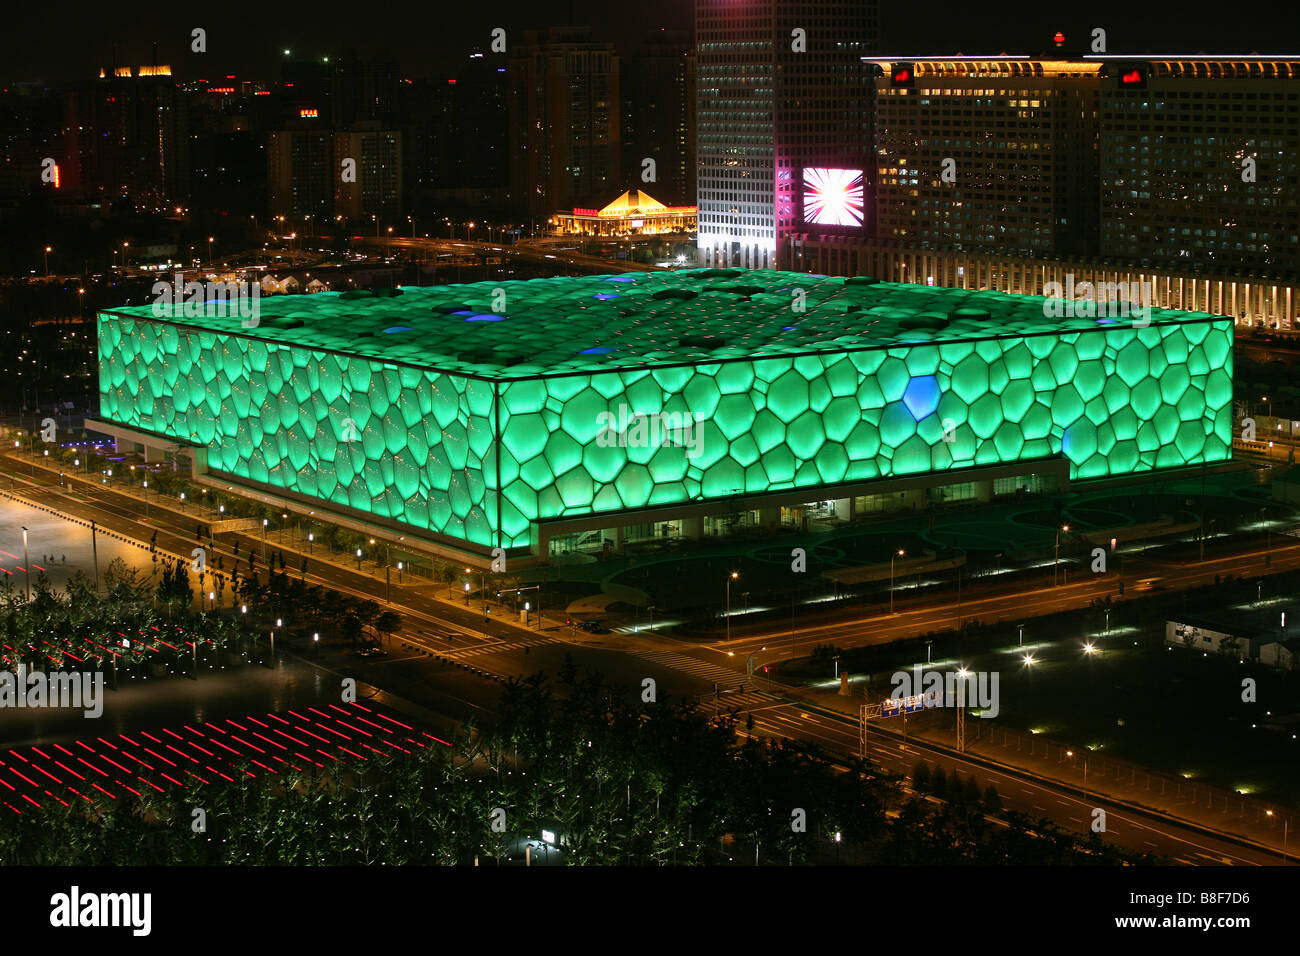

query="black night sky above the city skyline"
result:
[0,0,1300,83]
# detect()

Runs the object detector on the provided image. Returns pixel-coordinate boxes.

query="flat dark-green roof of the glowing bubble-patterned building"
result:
[104,269,1231,380]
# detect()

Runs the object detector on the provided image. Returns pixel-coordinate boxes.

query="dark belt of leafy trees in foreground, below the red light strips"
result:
[0,671,1159,865]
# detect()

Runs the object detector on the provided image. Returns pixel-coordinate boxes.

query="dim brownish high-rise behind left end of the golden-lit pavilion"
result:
[507,27,627,216]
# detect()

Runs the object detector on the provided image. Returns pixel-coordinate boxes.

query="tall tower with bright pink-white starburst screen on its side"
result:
[696,0,878,268]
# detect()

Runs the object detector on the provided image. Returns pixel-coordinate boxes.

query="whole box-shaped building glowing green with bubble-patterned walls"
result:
[99,269,1232,558]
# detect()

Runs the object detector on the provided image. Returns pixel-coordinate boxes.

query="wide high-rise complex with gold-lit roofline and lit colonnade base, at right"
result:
[795,50,1300,328]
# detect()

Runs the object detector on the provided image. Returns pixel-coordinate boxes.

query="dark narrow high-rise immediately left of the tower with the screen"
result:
[621,30,696,206]
